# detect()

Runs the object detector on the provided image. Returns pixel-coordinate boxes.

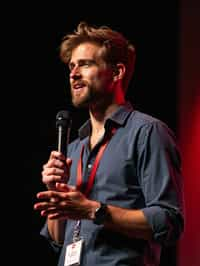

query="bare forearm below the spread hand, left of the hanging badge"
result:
[47,218,66,244]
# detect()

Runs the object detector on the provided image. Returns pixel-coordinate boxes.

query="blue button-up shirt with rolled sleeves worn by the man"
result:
[41,104,183,266]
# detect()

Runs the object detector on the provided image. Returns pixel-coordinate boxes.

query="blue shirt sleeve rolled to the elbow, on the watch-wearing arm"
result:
[138,121,184,244]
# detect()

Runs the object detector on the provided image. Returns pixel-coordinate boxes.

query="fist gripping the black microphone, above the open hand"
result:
[42,151,72,190]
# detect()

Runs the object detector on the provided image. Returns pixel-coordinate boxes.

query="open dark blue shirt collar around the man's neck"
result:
[78,102,133,139]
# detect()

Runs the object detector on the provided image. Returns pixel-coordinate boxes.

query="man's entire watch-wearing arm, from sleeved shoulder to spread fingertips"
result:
[35,121,183,242]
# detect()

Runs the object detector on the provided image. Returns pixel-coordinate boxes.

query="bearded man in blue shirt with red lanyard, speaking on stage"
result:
[34,22,184,266]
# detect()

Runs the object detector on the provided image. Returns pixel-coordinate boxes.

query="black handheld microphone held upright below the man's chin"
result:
[56,110,72,158]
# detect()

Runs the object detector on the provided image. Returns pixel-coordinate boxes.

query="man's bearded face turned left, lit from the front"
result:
[69,43,113,107]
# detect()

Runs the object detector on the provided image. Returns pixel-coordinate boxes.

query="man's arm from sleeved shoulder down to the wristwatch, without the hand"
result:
[89,120,184,244]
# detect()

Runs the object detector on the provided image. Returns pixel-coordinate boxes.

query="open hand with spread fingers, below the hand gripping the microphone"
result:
[34,183,98,220]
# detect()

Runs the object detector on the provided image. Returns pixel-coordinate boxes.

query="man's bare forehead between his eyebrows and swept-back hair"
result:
[71,43,100,61]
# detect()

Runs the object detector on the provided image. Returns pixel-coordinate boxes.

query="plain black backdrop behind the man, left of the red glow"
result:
[3,0,179,266]
